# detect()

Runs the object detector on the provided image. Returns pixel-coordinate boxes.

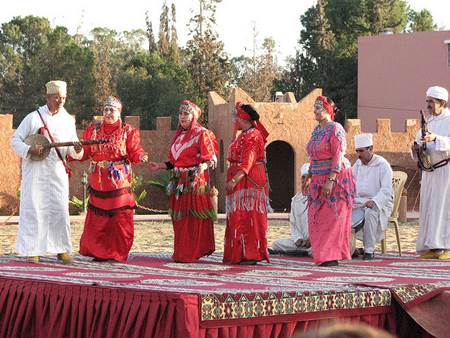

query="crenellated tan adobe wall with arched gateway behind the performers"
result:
[0,88,419,215]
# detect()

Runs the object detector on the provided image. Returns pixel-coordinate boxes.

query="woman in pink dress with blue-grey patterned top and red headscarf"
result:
[304,96,355,266]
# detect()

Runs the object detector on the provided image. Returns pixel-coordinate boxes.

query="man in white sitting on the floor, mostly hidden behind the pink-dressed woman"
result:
[269,163,311,256]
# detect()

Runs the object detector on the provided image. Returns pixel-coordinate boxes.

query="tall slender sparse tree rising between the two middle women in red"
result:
[185,0,231,115]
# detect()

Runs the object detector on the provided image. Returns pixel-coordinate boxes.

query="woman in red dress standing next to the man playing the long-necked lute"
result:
[76,96,148,262]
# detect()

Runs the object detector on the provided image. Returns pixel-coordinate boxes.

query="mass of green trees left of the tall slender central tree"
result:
[0,12,190,128]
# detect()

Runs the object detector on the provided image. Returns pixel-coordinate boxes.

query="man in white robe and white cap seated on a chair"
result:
[353,134,394,260]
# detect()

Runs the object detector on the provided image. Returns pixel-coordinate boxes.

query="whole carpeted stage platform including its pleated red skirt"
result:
[0,253,450,338]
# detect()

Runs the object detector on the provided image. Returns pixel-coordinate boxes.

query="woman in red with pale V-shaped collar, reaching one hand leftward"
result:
[150,100,218,263]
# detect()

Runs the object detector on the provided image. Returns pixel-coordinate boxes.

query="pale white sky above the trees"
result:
[0,0,450,61]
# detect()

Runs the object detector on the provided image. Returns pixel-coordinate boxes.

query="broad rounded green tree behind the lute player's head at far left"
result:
[0,16,94,125]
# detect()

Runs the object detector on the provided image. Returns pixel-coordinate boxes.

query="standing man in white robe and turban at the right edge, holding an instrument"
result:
[412,86,450,259]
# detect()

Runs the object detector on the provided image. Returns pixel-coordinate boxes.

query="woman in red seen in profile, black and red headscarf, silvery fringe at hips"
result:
[223,103,269,265]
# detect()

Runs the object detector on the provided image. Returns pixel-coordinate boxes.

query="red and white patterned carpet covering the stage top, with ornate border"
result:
[0,253,450,322]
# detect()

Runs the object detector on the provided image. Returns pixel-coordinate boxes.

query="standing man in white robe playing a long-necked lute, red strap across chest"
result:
[11,81,83,263]
